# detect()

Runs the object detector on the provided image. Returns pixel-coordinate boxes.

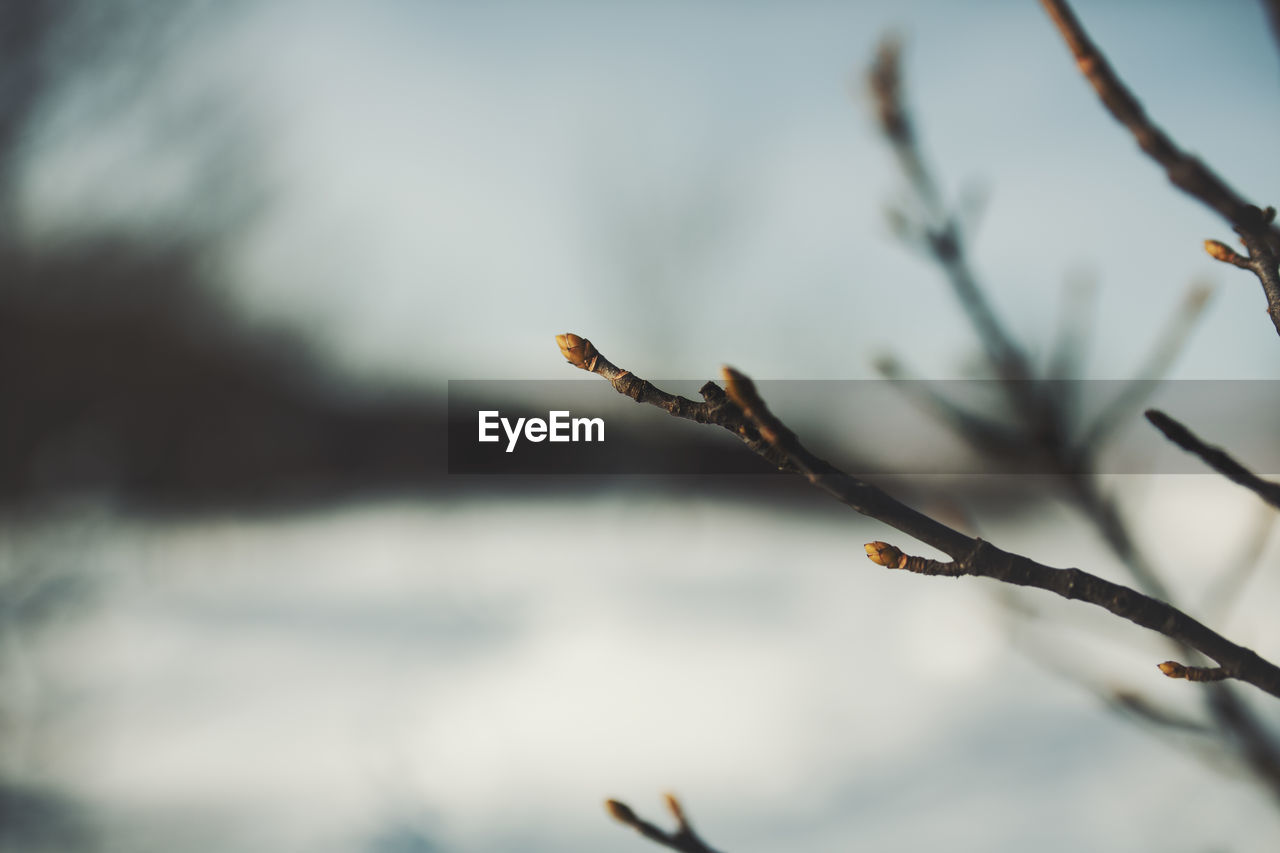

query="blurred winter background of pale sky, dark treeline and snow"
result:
[0,0,1280,853]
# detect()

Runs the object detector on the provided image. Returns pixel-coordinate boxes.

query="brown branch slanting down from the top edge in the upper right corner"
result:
[1041,0,1280,334]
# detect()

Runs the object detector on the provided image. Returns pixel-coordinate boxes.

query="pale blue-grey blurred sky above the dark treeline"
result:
[28,0,1280,379]
